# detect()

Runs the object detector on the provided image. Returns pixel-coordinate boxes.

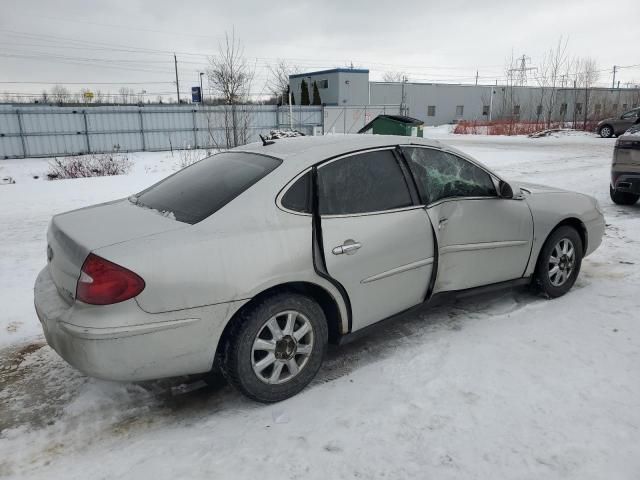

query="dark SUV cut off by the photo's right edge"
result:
[609,125,640,205]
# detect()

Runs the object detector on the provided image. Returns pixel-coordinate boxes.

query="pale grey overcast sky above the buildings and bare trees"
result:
[0,0,640,99]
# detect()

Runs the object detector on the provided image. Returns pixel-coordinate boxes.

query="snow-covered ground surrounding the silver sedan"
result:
[0,128,640,480]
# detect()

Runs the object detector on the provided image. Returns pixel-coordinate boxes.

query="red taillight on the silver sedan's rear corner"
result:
[76,253,144,305]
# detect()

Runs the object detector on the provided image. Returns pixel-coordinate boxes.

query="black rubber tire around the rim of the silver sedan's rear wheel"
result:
[220,293,328,403]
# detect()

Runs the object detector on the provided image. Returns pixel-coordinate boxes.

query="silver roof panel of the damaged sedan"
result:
[233,134,442,167]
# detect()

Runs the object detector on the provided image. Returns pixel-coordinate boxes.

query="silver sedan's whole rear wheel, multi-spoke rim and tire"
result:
[221,293,328,403]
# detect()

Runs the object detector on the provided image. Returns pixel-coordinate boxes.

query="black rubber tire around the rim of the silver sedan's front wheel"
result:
[534,225,583,298]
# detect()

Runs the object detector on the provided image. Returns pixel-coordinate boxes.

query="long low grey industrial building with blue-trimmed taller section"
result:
[289,68,640,125]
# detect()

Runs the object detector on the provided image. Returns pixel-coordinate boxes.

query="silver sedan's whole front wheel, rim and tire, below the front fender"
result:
[535,226,583,298]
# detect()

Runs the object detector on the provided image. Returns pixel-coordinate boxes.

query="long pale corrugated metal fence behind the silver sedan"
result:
[0,105,399,159]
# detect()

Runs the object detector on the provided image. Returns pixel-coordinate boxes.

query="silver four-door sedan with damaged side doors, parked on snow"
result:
[35,135,604,402]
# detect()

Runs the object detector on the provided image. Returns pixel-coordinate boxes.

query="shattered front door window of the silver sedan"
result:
[403,147,497,204]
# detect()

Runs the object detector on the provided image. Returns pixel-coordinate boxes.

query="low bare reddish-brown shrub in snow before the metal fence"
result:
[47,153,132,180]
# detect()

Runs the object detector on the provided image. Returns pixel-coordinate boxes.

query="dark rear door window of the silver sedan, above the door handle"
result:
[318,150,412,215]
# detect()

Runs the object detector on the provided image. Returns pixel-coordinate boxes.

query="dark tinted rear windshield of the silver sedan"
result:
[131,152,281,224]
